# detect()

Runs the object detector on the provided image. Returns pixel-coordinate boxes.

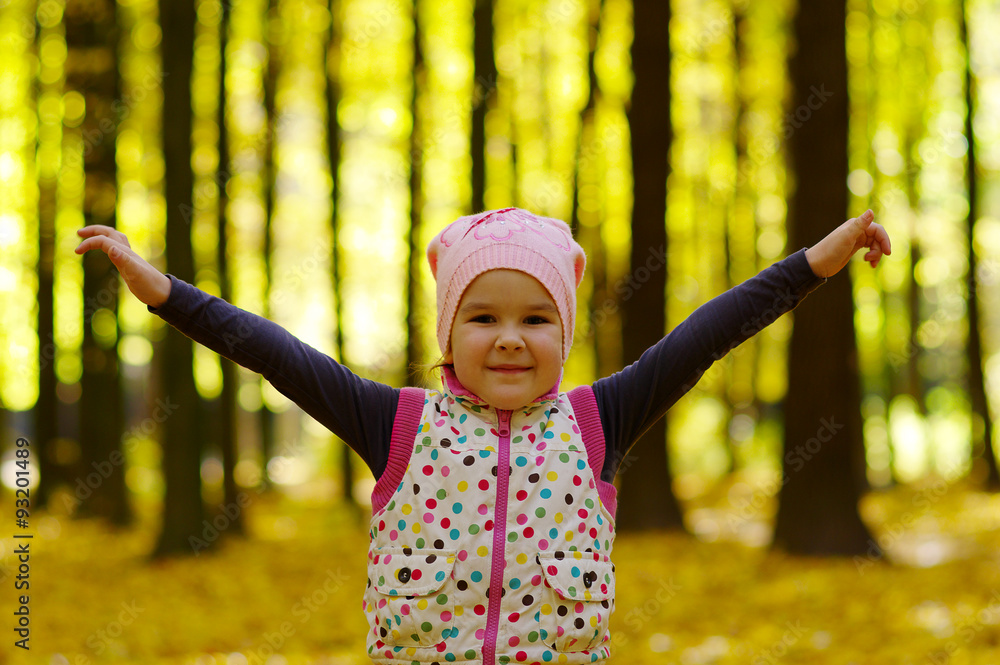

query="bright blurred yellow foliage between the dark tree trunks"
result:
[0,0,1000,660]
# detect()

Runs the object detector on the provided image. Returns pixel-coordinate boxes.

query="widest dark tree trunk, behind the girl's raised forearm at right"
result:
[774,0,877,555]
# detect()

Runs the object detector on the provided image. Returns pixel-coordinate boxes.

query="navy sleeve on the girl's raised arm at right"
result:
[593,249,826,482]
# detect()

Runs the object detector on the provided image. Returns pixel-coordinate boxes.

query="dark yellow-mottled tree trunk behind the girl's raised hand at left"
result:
[63,0,131,525]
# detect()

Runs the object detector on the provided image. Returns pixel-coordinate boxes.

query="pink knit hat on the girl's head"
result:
[427,208,587,362]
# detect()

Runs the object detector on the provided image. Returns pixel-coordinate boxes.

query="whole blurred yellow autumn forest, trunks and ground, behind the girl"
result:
[0,0,1000,663]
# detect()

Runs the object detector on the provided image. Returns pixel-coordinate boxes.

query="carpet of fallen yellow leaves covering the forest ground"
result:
[0,483,1000,665]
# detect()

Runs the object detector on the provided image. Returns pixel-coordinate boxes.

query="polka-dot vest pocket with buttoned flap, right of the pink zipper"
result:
[535,551,615,651]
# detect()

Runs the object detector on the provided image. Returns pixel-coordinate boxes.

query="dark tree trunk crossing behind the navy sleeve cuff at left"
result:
[154,0,205,557]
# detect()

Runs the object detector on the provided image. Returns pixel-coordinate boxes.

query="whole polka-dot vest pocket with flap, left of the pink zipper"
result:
[371,547,455,646]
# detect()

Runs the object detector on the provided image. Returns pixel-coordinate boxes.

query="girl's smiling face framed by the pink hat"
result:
[444,270,562,410]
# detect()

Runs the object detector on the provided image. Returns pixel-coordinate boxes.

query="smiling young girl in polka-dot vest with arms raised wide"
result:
[76,208,890,665]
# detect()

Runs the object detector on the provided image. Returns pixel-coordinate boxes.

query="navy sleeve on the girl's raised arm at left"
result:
[147,275,399,478]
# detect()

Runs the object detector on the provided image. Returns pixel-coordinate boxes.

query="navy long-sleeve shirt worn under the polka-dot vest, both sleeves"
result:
[148,249,826,482]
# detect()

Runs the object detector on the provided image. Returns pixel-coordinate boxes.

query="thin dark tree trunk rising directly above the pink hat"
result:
[471,0,497,213]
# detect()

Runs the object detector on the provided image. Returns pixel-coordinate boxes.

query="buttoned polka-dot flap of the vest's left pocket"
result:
[372,547,455,596]
